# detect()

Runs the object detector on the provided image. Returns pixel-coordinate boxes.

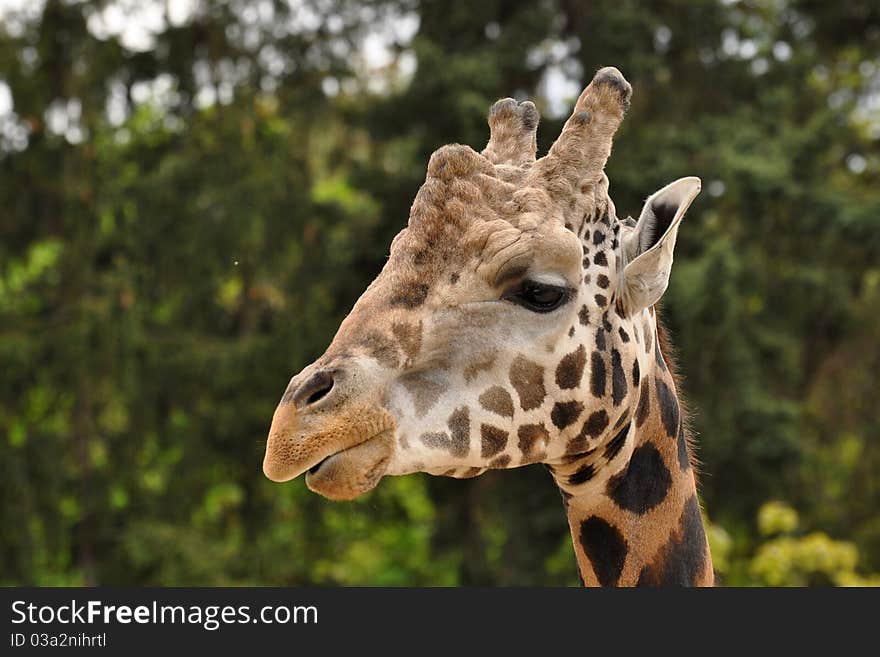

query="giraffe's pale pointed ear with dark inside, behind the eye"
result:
[622,177,701,313]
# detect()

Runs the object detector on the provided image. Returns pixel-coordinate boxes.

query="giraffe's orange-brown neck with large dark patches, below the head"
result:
[554,326,714,586]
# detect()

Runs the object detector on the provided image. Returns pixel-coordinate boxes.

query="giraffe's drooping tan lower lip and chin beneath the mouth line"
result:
[306,429,394,500]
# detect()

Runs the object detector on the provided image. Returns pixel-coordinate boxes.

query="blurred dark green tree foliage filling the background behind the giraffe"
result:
[0,0,880,585]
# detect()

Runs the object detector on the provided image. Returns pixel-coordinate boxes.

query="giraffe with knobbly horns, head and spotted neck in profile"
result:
[263,67,714,586]
